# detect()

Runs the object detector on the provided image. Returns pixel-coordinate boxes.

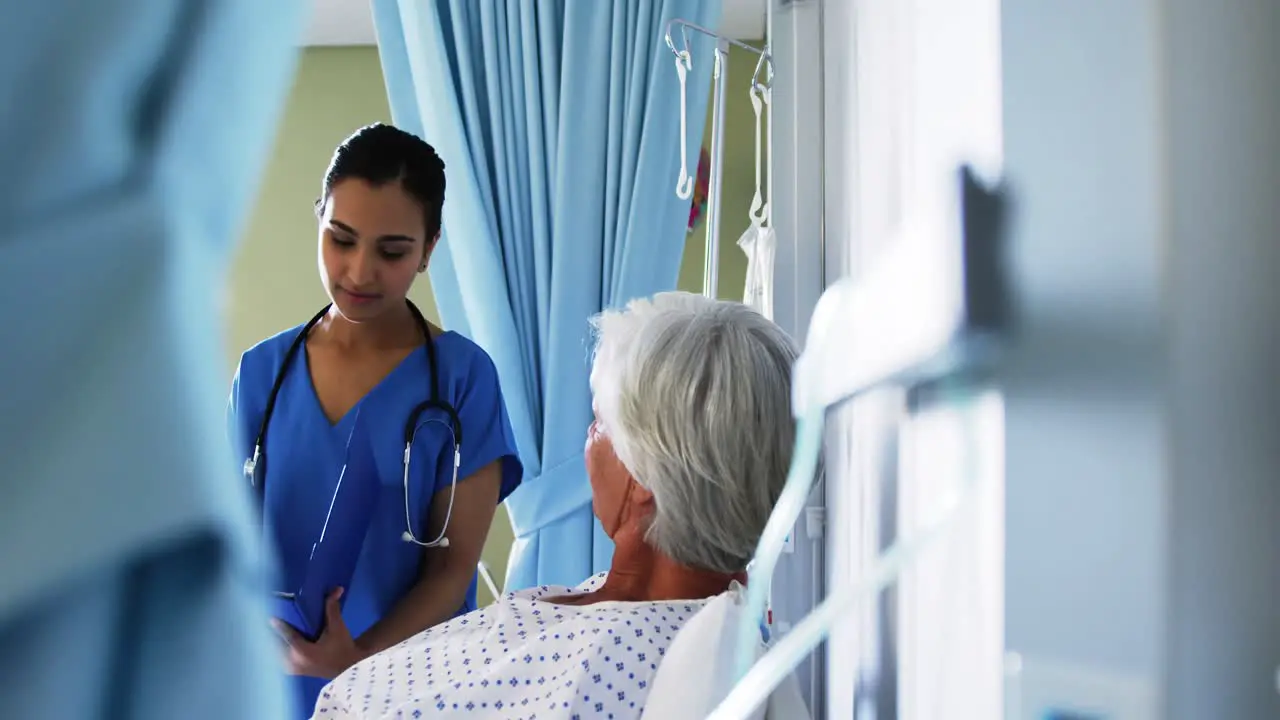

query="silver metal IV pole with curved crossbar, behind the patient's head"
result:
[664,18,773,299]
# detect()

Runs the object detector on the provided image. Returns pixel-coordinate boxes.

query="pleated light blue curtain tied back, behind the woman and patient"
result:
[374,0,721,589]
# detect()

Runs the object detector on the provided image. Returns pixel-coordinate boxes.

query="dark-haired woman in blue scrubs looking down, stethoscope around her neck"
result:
[228,124,521,717]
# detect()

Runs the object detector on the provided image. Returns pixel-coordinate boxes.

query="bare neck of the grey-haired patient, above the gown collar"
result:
[552,517,746,605]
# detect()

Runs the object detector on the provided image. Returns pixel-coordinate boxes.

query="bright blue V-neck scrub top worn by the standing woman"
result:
[228,325,522,717]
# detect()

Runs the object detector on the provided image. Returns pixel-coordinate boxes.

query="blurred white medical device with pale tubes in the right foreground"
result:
[712,168,1009,720]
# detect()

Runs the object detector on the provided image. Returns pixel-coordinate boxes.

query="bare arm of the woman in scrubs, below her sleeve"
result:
[356,460,502,657]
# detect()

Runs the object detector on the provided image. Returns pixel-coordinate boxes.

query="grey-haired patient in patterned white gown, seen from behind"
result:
[315,292,796,720]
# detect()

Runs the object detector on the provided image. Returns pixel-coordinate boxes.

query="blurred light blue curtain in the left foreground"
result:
[0,0,305,720]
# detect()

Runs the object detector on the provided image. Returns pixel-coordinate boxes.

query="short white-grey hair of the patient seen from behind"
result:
[591,292,796,573]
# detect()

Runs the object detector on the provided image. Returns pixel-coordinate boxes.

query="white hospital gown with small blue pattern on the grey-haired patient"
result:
[314,573,707,720]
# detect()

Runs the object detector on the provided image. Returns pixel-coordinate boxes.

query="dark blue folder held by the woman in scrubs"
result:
[273,410,380,642]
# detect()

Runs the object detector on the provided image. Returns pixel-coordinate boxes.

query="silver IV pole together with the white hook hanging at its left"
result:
[663,18,773,297]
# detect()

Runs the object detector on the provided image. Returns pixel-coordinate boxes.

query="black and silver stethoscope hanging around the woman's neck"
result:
[244,300,462,547]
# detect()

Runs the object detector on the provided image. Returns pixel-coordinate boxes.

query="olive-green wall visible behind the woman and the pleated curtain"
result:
[227,47,755,602]
